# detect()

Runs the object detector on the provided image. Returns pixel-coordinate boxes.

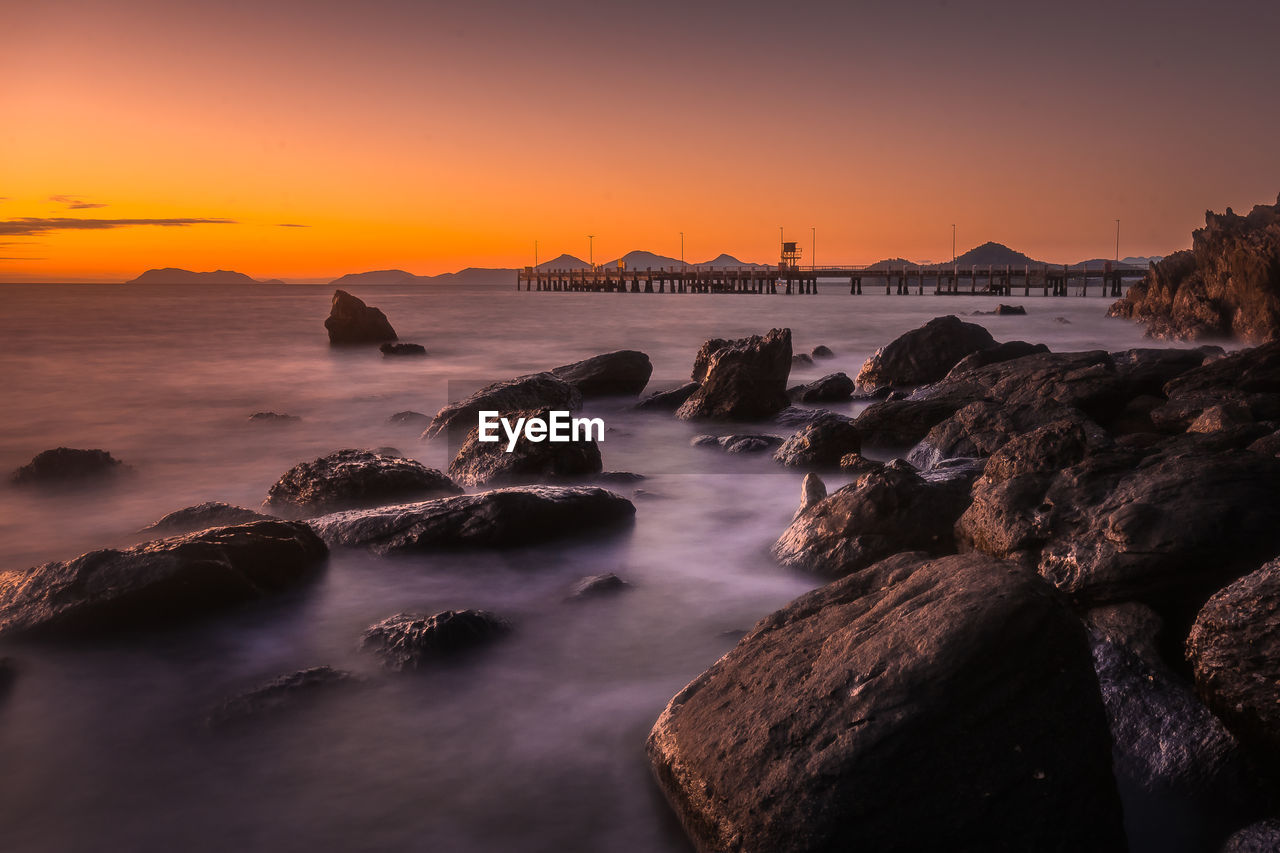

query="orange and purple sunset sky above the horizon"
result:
[0,0,1280,282]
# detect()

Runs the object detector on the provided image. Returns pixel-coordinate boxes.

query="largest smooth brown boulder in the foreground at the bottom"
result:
[648,555,1125,853]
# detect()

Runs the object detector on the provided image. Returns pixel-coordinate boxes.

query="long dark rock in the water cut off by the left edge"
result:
[0,521,328,634]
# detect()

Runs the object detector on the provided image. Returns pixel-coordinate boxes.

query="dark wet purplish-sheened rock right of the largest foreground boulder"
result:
[1087,603,1262,835]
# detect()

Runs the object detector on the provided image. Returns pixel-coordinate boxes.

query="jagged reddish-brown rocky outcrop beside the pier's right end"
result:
[1110,200,1280,343]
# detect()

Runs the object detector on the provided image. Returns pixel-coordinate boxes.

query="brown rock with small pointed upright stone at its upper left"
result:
[772,458,969,578]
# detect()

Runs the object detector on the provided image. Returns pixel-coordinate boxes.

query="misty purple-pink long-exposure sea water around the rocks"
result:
[0,282,1143,852]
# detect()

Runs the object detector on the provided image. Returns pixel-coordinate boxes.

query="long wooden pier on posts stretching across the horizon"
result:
[516,264,1147,297]
